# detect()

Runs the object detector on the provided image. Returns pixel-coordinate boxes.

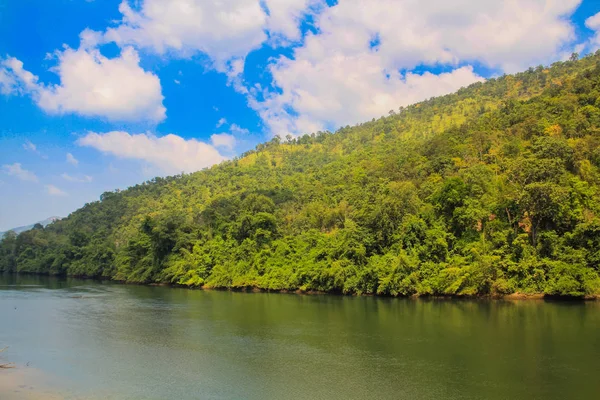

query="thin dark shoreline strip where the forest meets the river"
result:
[3,272,600,302]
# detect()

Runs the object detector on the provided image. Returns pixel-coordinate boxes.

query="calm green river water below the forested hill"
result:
[0,277,600,399]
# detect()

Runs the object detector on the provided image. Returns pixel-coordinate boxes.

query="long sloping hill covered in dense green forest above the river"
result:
[0,54,600,296]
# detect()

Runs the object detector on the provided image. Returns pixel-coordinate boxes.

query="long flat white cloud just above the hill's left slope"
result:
[77,131,226,173]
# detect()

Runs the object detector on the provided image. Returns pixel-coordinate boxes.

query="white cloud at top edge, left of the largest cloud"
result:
[103,0,324,67]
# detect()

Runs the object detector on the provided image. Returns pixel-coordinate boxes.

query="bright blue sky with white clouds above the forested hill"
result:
[0,0,600,231]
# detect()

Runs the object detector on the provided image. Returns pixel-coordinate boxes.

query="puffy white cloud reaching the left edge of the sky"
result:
[0,44,166,122]
